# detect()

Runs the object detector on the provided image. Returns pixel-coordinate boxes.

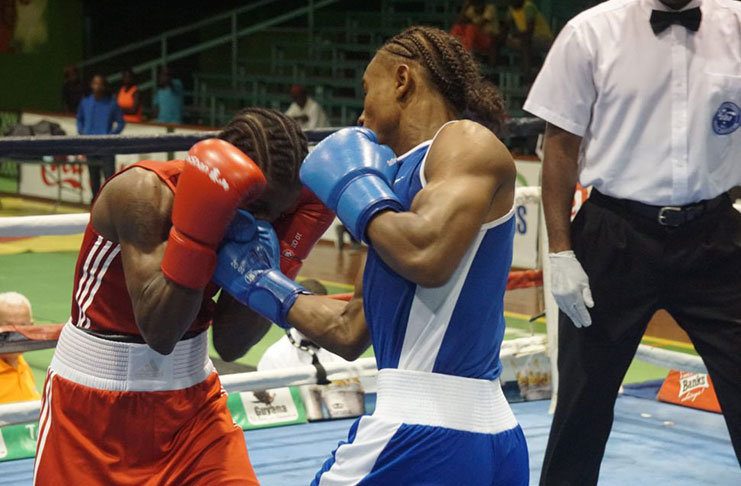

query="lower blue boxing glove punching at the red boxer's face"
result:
[213,210,310,329]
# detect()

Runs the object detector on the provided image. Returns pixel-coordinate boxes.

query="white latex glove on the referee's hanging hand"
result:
[548,251,594,327]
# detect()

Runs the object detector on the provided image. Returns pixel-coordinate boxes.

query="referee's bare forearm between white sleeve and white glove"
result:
[543,123,582,253]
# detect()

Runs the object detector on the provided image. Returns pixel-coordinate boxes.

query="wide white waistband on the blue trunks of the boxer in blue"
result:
[373,368,517,434]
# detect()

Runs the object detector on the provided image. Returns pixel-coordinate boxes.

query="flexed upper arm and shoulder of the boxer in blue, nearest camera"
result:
[367,121,516,287]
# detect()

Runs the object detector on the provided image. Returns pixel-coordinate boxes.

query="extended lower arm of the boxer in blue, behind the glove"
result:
[287,262,371,361]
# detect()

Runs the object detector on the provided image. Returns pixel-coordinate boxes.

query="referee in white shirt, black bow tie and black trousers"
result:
[525,0,741,486]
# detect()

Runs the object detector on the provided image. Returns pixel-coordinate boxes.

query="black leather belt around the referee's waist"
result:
[589,189,731,228]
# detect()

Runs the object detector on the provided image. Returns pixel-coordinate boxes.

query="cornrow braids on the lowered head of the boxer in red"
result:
[218,108,309,188]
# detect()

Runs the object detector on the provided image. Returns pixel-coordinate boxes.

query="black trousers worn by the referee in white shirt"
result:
[540,195,741,486]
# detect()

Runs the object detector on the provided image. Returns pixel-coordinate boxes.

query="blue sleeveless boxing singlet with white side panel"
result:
[363,124,515,380]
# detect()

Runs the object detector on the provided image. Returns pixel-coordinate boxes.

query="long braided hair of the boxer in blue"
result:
[379,26,504,132]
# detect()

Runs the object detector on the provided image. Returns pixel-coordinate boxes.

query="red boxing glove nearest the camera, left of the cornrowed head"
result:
[161,138,267,289]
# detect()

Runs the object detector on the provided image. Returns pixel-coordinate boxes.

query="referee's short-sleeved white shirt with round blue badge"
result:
[524,0,741,205]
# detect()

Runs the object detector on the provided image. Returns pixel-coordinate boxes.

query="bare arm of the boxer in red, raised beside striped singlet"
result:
[92,169,203,354]
